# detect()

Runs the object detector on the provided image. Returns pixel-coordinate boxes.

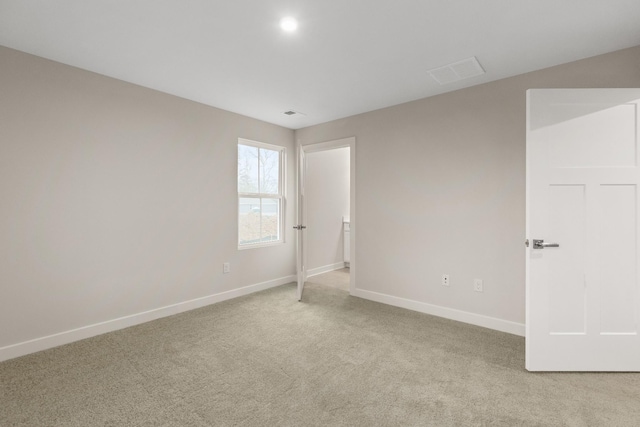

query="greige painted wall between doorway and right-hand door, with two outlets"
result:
[296,47,640,330]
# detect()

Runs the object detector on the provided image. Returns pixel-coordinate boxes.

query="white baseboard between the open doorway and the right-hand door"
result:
[353,289,525,337]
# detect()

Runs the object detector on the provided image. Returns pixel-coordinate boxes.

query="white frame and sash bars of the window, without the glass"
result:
[236,138,287,250]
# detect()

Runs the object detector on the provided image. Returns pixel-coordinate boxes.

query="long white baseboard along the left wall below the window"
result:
[0,275,296,362]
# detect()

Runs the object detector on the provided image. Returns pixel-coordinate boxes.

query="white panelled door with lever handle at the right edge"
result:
[526,89,640,371]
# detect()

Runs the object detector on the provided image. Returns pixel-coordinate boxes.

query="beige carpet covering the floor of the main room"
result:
[0,276,640,427]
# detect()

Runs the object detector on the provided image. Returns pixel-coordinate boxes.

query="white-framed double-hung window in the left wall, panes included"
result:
[238,139,284,248]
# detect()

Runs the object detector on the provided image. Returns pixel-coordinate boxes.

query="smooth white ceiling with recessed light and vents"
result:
[0,0,640,129]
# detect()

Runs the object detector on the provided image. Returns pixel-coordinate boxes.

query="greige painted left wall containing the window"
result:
[0,47,295,354]
